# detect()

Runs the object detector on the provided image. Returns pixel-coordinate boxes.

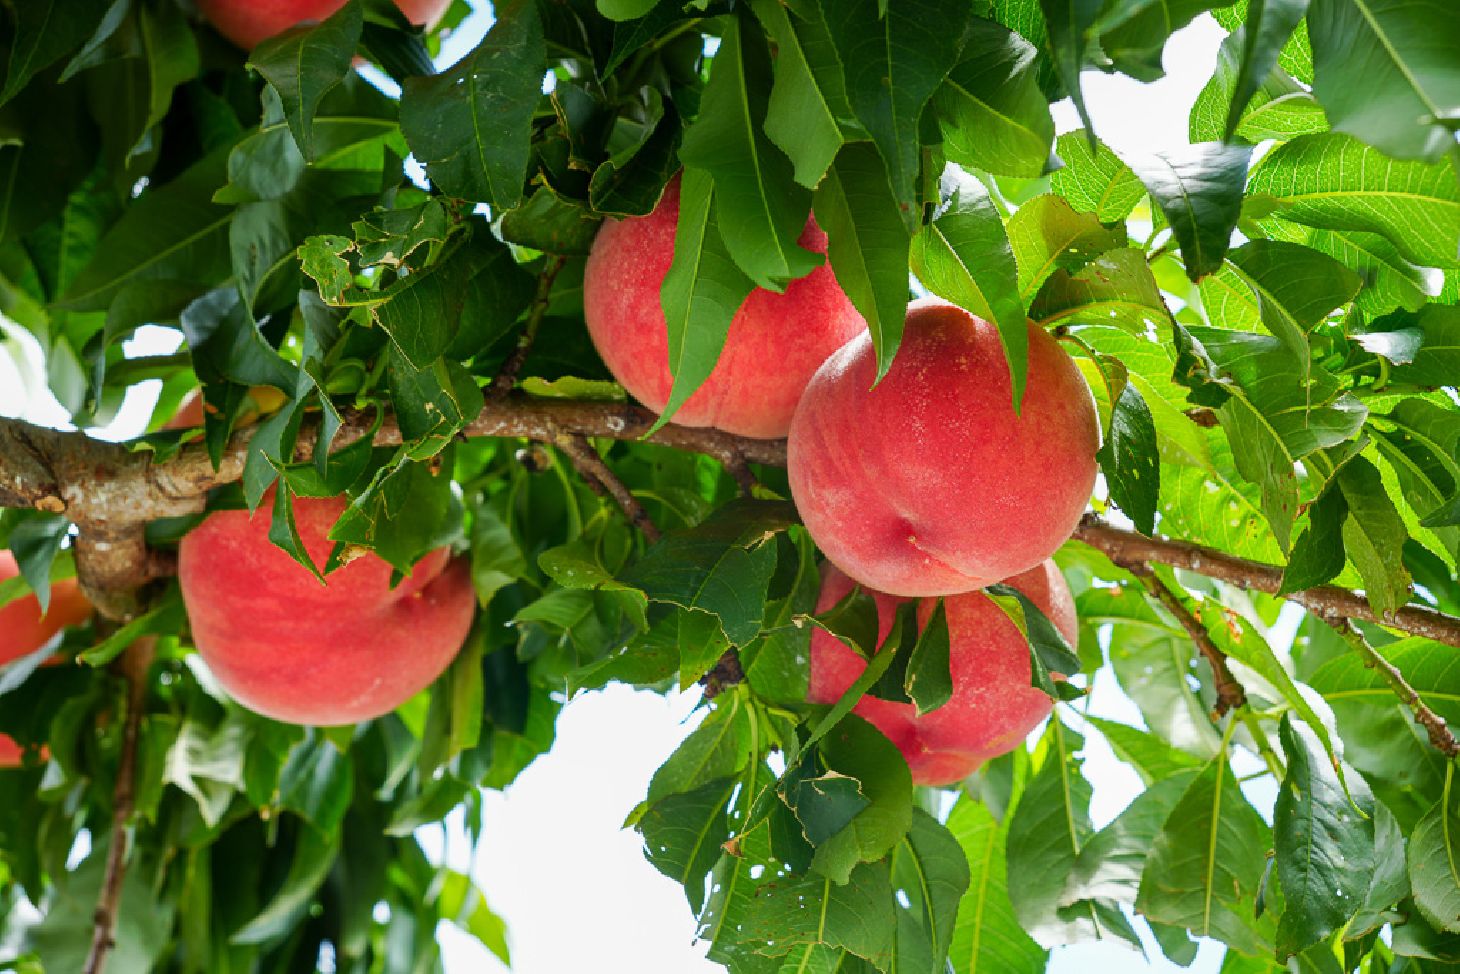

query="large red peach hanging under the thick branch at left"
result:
[178,491,476,726]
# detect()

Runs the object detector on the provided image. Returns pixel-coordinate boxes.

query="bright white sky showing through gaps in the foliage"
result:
[0,9,1294,974]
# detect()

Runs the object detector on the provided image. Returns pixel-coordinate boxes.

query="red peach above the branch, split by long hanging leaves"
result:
[583,177,866,440]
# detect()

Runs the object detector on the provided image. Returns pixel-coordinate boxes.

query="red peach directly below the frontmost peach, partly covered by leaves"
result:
[807,561,1079,784]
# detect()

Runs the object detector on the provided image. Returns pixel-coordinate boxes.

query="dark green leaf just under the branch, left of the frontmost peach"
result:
[621,501,796,645]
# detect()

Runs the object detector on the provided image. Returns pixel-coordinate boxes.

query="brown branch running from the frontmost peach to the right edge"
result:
[1073,514,1460,647]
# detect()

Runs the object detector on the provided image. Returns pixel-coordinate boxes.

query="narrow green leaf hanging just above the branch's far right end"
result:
[1337,457,1410,616]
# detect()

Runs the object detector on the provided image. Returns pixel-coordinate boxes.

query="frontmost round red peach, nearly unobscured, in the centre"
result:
[787,301,1099,596]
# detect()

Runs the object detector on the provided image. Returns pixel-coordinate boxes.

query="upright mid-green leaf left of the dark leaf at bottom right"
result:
[1136,752,1270,954]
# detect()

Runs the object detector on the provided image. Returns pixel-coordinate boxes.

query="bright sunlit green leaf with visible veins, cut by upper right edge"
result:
[1247,131,1460,267]
